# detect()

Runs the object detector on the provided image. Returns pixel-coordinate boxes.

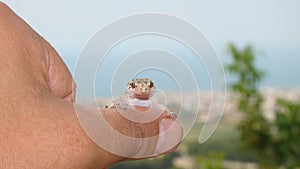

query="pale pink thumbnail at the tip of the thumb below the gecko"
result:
[155,118,182,154]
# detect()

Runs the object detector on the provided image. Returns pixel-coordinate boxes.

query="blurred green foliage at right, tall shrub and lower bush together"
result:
[227,44,300,168]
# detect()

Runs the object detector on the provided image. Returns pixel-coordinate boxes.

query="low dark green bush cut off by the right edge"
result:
[273,99,300,168]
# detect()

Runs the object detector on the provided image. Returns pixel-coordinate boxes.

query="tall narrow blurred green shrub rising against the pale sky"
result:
[227,44,270,164]
